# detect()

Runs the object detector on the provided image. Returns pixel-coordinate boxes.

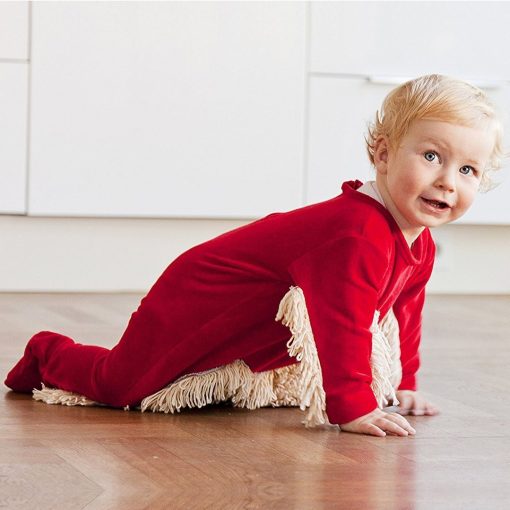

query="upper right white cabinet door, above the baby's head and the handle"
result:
[311,1,510,80]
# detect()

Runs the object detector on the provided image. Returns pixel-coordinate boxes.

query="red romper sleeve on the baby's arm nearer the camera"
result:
[289,237,389,424]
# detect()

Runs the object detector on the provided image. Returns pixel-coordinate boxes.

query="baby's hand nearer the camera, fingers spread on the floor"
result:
[340,409,416,437]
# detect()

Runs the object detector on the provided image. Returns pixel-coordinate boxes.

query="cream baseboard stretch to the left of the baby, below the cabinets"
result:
[0,216,247,292]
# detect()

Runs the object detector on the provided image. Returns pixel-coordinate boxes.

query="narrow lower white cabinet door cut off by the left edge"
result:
[0,62,28,214]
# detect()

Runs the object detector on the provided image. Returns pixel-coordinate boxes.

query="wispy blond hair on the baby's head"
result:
[365,74,506,191]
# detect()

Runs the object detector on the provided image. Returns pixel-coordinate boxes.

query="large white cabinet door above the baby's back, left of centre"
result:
[29,2,306,218]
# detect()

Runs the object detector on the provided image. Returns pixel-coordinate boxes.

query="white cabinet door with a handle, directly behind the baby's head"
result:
[306,77,510,224]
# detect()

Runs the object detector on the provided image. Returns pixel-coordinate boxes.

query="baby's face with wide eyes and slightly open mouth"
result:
[376,120,495,237]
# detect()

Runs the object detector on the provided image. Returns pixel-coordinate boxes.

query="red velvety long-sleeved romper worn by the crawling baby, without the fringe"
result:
[5,181,434,424]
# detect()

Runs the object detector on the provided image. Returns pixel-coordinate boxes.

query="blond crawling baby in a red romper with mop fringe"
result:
[5,75,502,436]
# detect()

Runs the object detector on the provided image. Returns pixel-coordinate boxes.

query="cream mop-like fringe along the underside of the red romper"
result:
[33,287,401,427]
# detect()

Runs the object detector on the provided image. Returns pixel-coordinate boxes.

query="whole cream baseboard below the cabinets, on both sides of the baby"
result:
[0,216,510,294]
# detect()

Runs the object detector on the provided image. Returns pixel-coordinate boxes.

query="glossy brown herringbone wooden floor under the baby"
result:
[0,294,510,510]
